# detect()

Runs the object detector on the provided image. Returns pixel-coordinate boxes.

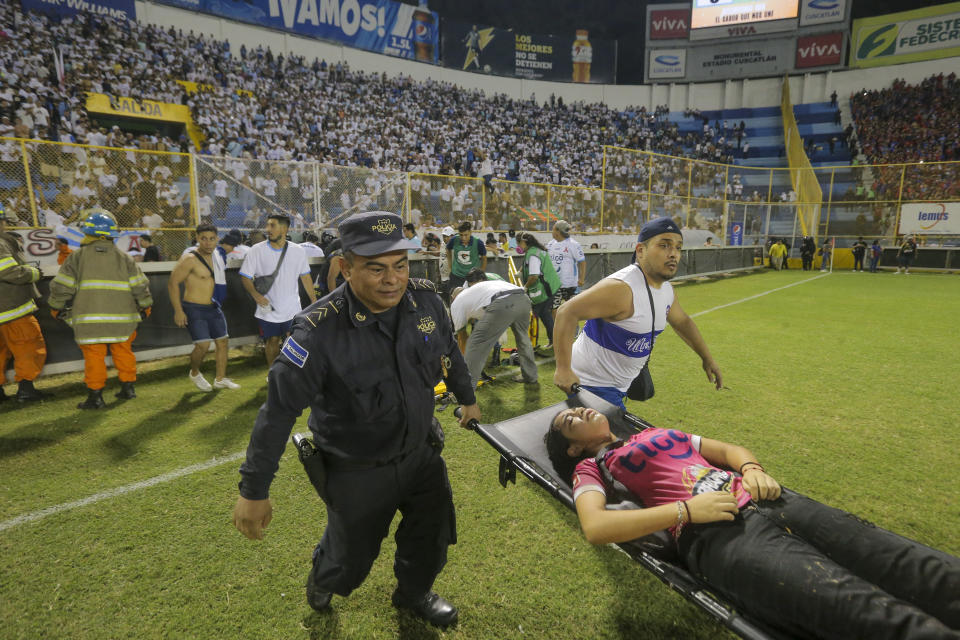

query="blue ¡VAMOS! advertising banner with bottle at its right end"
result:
[150,0,440,64]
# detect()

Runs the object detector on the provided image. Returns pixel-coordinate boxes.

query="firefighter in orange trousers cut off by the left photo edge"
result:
[0,207,50,402]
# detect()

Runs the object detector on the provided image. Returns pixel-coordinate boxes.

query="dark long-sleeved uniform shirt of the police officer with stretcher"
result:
[240,278,476,500]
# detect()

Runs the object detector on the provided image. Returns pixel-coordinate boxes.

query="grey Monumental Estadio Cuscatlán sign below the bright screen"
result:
[686,38,795,82]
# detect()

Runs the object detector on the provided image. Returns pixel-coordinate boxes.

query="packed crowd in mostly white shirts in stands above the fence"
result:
[0,4,727,195]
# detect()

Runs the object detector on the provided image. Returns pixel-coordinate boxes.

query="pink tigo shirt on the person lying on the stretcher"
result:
[573,429,750,532]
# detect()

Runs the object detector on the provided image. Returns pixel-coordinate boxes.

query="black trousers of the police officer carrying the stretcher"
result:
[311,443,457,597]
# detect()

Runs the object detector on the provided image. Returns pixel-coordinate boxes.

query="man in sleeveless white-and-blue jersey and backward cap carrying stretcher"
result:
[553,218,723,407]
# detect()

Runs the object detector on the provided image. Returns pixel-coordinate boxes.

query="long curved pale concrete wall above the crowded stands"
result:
[136,0,960,111]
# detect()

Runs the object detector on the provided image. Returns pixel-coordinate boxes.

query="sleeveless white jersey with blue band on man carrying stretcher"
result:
[571,265,673,391]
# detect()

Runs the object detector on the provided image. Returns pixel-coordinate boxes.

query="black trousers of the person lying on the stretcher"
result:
[680,492,960,640]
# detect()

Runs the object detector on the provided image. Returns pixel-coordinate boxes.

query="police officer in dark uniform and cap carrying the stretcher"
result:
[233,211,480,626]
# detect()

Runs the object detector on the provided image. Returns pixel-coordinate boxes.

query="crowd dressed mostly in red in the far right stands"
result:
[850,73,960,200]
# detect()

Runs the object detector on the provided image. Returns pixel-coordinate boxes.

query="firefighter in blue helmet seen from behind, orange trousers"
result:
[49,209,153,409]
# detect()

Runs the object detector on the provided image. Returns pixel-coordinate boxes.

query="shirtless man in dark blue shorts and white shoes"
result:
[167,222,240,391]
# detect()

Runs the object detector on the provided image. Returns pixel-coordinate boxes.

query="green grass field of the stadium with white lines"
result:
[0,271,960,640]
